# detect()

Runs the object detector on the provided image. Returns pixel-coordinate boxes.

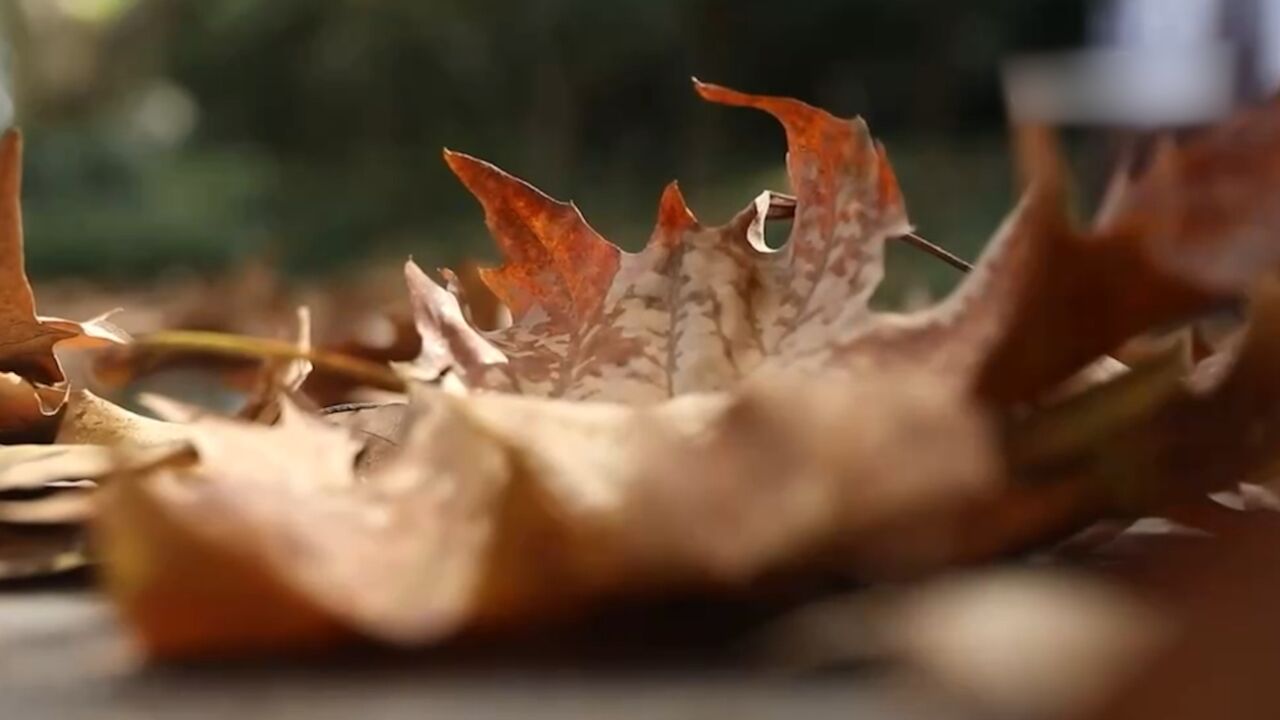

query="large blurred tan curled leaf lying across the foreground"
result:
[99,375,998,656]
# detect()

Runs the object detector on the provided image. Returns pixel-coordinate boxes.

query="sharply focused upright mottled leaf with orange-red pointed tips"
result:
[419,85,909,402]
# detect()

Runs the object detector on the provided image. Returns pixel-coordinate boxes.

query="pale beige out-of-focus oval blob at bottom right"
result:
[888,570,1170,717]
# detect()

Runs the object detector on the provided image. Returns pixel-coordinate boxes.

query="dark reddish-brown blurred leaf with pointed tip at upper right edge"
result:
[977,101,1280,402]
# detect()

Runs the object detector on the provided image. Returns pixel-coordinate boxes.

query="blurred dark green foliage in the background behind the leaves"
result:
[0,0,1085,295]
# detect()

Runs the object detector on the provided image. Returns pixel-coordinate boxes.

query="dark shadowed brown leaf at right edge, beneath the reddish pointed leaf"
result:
[1007,278,1280,516]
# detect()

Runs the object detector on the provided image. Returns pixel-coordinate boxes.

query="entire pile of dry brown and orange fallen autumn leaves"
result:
[0,85,1280,716]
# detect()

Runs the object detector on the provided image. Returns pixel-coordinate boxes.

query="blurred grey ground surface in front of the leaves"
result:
[0,587,964,720]
